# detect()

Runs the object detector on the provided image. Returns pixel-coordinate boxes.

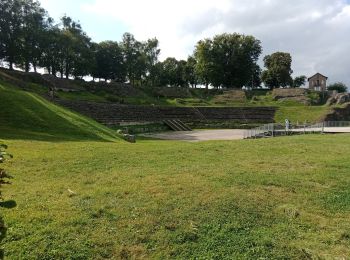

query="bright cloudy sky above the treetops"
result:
[39,0,350,86]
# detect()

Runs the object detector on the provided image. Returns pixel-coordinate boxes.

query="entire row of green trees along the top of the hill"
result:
[0,0,306,88]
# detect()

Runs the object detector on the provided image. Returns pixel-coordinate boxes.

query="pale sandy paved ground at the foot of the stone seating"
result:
[143,129,245,142]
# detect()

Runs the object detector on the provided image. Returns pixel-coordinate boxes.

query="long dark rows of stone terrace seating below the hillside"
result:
[56,100,275,125]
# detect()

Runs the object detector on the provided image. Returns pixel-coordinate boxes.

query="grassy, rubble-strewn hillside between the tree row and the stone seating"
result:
[0,69,333,126]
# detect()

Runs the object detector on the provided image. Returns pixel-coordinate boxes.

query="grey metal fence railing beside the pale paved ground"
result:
[244,121,350,139]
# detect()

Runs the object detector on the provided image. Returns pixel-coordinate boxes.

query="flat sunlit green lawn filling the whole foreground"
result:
[0,135,350,259]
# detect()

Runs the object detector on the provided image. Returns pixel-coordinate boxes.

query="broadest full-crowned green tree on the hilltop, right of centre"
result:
[194,33,262,88]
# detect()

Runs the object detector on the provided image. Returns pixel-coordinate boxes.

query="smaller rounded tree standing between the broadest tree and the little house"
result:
[261,52,293,89]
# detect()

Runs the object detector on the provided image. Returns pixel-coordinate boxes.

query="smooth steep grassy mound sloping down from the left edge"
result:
[0,83,116,141]
